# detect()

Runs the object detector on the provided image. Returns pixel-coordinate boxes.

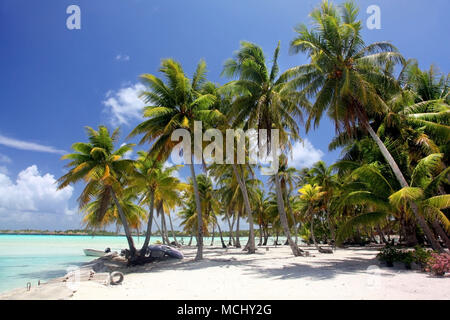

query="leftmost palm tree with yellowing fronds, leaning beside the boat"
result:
[58,126,136,258]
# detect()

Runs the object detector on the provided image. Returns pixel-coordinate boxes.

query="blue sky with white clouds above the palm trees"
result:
[0,0,450,229]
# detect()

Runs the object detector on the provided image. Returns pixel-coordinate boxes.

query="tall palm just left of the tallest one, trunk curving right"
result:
[223,41,301,256]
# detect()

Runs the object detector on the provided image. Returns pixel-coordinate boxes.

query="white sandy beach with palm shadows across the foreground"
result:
[0,246,450,300]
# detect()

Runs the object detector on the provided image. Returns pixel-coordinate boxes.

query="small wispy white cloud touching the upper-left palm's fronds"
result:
[103,83,145,126]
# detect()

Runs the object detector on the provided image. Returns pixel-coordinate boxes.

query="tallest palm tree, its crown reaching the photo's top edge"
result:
[287,0,440,249]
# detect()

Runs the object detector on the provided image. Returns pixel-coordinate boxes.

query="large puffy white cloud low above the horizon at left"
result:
[0,165,76,219]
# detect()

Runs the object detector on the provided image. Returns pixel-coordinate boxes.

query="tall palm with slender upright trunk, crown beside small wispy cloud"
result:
[130,59,221,260]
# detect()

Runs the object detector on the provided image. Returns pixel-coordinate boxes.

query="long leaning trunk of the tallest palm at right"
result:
[362,121,442,251]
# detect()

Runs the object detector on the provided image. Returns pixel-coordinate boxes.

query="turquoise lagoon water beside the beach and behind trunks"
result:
[0,235,239,292]
